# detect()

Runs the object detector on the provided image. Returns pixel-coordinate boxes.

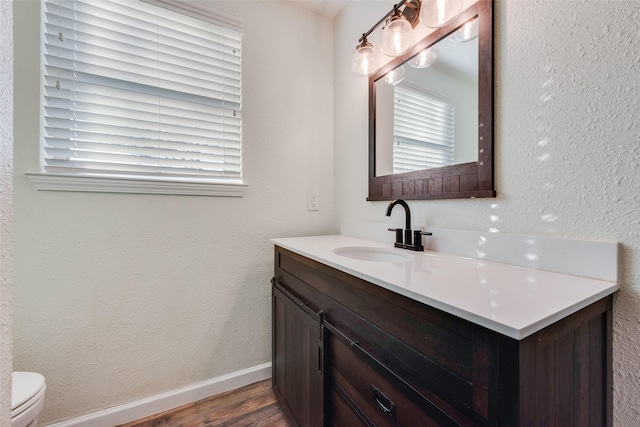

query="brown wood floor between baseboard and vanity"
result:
[120,379,291,427]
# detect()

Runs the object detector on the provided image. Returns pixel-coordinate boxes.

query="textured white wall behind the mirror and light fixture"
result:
[334,0,640,426]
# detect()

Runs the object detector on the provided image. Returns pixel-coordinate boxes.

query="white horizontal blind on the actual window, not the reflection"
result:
[42,0,242,182]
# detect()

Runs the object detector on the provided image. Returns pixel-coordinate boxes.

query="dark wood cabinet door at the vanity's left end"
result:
[273,281,324,427]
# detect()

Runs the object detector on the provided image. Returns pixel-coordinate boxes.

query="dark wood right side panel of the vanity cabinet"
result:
[505,297,612,427]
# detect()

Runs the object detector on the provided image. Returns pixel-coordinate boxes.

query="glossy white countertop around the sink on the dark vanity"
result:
[271,235,619,339]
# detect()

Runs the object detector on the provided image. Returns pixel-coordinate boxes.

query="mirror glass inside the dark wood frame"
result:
[374,32,478,176]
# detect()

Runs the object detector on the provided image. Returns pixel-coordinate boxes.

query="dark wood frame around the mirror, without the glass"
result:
[367,0,496,201]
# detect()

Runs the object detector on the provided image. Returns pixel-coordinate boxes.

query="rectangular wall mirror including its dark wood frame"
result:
[367,0,495,201]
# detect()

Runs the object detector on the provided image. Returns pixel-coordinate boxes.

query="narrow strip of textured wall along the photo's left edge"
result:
[0,0,13,426]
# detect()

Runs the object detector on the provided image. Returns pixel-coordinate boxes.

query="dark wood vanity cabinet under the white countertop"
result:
[273,247,612,427]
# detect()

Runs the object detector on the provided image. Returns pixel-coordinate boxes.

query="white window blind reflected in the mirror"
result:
[393,83,455,174]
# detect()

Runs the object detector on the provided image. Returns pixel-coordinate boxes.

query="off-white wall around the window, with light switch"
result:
[12,0,336,424]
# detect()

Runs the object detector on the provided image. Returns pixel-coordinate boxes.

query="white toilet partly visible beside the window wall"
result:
[11,372,47,427]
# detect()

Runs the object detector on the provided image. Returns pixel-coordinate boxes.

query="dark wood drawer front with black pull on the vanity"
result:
[325,322,471,427]
